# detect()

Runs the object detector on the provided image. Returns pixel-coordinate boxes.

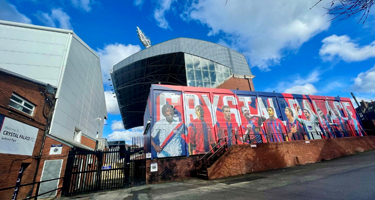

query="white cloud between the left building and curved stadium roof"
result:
[97,43,141,84]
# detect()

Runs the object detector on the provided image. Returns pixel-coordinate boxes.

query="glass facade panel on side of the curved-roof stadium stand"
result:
[185,53,233,88]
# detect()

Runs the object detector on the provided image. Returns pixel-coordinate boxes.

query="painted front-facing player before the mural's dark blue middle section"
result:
[263,107,286,142]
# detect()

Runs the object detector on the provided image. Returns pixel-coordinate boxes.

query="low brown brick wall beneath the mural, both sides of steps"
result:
[146,136,375,184]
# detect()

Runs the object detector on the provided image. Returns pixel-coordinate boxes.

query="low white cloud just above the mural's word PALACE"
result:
[267,70,320,94]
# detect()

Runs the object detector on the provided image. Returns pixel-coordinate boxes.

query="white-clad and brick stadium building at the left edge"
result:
[0,21,107,199]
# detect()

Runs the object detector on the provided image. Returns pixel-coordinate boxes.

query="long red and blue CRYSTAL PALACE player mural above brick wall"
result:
[145,85,366,158]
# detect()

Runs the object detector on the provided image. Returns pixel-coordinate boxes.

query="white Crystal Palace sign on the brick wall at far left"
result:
[0,115,38,156]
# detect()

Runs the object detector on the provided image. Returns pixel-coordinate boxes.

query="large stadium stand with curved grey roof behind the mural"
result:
[112,38,254,129]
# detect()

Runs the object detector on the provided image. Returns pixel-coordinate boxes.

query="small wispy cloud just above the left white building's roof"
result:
[36,8,73,30]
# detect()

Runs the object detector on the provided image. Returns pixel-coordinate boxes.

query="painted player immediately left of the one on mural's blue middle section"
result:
[241,106,267,143]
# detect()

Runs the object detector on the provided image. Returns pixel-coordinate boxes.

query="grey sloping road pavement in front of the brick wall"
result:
[59,151,375,200]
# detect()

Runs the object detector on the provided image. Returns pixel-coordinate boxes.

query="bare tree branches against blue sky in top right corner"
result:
[310,0,375,23]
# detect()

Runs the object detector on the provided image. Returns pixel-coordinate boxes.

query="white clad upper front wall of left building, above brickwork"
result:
[0,21,72,87]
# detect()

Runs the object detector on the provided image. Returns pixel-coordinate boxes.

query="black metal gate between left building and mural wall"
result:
[63,138,146,196]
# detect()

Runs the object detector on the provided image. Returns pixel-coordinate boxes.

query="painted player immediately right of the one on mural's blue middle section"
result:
[285,107,309,140]
